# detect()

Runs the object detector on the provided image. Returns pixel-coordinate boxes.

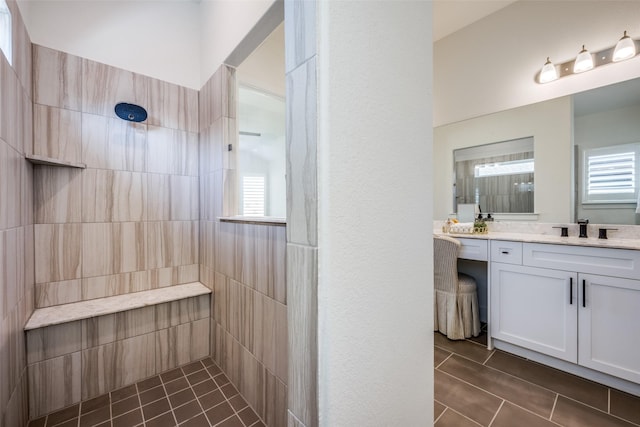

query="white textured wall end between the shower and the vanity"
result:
[318,1,433,426]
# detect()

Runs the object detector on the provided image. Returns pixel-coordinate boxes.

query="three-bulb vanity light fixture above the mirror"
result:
[537,31,640,84]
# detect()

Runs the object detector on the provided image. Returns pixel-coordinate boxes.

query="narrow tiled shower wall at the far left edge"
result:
[0,0,34,427]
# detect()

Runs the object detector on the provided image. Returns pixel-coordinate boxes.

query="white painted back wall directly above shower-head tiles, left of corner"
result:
[18,0,201,89]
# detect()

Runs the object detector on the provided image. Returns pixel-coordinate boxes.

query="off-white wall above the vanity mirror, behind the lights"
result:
[434,0,640,126]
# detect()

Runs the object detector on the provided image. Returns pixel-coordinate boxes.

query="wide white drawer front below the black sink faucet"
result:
[522,243,640,279]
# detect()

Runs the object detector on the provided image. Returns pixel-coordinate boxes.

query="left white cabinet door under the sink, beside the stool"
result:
[490,263,578,363]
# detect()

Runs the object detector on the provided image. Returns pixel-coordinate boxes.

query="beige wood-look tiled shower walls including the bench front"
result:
[0,2,287,426]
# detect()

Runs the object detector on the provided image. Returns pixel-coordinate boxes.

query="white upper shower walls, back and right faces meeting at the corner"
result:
[18,0,274,89]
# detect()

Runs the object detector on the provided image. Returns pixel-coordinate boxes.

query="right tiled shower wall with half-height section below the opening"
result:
[200,66,287,427]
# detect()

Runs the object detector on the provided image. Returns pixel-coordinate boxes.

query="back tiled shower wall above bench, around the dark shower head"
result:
[33,45,198,307]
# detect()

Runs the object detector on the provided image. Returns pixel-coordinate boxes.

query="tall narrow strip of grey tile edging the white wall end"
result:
[284,0,319,427]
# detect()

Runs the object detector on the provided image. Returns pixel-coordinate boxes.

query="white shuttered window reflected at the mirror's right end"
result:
[582,143,640,203]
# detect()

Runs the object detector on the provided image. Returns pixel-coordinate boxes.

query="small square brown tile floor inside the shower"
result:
[29,358,264,427]
